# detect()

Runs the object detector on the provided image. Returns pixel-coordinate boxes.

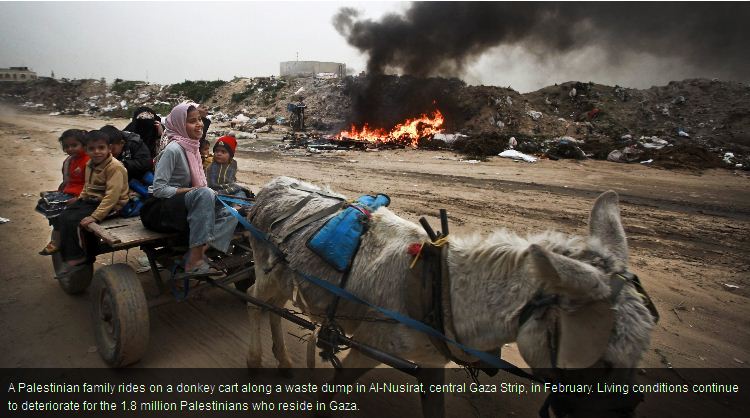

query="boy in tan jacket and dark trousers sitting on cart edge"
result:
[57,131,128,274]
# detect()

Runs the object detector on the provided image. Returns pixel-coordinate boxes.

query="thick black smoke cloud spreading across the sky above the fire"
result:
[333,2,750,81]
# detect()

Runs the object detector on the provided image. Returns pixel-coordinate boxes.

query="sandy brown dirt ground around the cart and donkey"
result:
[0,107,750,414]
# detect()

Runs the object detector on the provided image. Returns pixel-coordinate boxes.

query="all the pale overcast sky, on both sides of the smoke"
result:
[0,2,748,92]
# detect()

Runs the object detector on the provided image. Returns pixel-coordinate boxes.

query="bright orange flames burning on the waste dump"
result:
[336,110,445,148]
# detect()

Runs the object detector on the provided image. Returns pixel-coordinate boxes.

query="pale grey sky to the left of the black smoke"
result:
[0,2,407,83]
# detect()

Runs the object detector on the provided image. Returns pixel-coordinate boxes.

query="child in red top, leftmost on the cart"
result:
[37,129,89,255]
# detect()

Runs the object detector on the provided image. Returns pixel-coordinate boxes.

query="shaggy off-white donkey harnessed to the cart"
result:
[247,177,655,416]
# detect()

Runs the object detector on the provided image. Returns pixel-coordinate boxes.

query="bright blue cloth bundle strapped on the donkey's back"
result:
[307,194,391,272]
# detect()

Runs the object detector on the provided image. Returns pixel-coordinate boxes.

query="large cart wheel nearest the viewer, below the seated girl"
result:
[91,264,149,367]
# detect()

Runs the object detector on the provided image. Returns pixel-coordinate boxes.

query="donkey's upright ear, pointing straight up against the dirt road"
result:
[589,190,628,264]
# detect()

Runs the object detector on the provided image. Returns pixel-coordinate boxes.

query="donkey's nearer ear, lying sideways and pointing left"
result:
[528,244,609,299]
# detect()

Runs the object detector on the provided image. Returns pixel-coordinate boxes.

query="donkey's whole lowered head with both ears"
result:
[517,191,655,369]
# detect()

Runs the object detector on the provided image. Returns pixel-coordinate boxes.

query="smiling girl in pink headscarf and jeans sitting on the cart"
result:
[141,103,237,274]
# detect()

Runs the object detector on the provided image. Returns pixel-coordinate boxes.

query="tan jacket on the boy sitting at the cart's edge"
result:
[80,154,129,222]
